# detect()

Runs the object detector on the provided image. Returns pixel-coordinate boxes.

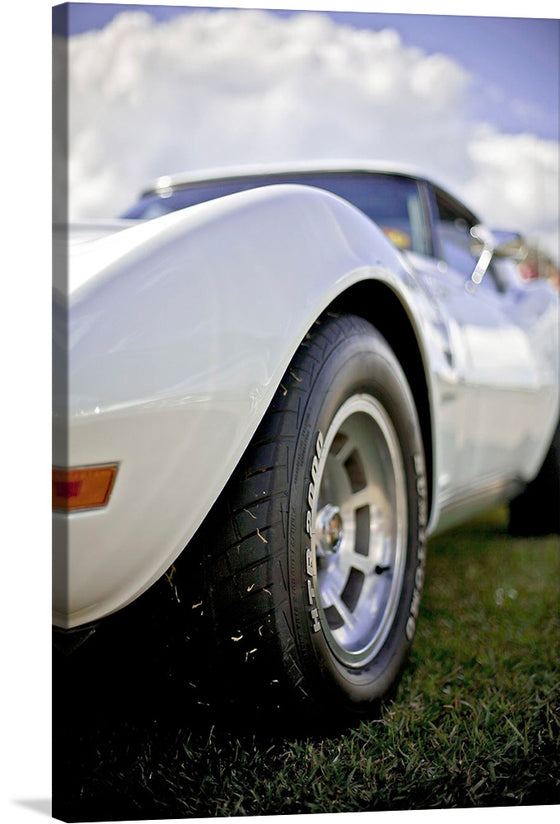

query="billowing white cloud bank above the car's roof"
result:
[59,10,558,260]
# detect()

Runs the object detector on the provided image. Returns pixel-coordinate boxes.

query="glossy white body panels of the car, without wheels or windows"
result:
[53,167,559,628]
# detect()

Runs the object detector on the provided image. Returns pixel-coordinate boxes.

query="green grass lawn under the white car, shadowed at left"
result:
[53,510,560,820]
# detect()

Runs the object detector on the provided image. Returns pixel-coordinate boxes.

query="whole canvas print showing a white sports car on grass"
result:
[52,3,560,821]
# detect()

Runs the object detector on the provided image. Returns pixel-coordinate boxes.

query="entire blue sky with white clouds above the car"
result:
[54,0,560,256]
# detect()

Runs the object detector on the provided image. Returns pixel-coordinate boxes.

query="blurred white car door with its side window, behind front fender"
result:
[427,187,552,494]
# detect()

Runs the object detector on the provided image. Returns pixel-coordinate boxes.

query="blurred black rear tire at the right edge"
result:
[509,424,560,537]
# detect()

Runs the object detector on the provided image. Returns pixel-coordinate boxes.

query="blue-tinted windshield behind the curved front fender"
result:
[122,172,432,255]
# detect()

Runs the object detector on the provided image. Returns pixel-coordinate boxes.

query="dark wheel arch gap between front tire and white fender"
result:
[326,280,435,516]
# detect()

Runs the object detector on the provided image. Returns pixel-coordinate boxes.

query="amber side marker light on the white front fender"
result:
[53,464,117,512]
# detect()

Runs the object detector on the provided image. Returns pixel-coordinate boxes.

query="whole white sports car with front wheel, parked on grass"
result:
[53,162,560,713]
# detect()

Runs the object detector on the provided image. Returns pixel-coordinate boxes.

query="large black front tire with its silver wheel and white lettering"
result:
[195,316,427,719]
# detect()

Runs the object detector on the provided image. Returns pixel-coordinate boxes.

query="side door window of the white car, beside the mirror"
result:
[435,189,496,290]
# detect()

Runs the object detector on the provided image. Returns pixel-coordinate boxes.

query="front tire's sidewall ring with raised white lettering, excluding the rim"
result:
[288,325,427,709]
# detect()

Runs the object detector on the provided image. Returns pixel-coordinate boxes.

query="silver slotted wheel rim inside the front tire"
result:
[312,394,407,668]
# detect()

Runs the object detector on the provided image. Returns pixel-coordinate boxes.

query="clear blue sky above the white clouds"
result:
[53,3,560,140]
